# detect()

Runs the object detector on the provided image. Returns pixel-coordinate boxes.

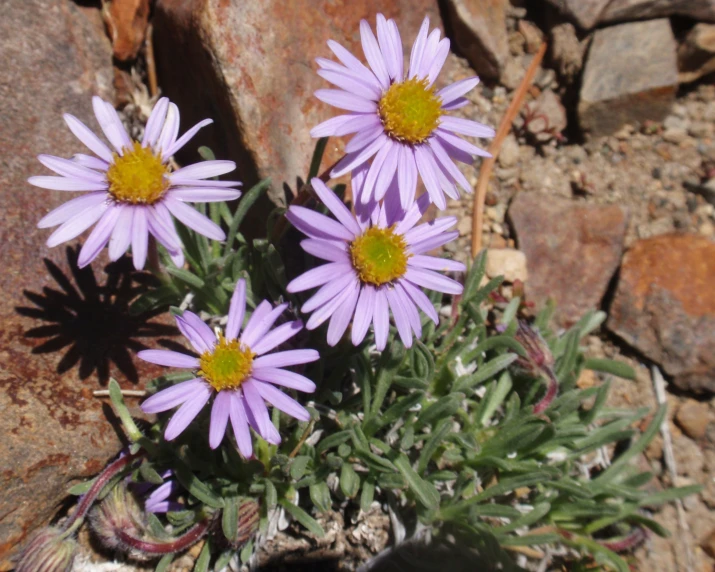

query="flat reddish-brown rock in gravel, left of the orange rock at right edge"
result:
[509,193,628,326]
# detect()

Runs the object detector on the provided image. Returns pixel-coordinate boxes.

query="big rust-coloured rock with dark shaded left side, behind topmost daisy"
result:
[153,0,440,206]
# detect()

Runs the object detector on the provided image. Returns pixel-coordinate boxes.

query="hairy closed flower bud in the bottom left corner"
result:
[15,526,77,572]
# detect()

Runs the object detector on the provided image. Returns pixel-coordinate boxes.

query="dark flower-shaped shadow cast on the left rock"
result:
[16,247,178,385]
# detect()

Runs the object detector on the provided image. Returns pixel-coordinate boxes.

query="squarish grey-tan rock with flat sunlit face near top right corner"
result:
[578,19,678,136]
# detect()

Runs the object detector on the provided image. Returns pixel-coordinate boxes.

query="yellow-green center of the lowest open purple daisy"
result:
[199,334,256,391]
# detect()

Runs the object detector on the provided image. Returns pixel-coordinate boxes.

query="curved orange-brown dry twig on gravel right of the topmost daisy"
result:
[472,42,546,258]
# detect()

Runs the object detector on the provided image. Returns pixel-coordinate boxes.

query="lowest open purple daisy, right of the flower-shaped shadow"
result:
[137,280,319,458]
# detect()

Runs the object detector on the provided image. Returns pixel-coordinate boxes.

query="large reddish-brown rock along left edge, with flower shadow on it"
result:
[0,0,169,570]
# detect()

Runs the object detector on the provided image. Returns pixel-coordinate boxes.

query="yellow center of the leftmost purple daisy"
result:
[107,141,169,205]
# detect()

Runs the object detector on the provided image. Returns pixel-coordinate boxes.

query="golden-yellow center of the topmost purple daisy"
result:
[378,78,442,144]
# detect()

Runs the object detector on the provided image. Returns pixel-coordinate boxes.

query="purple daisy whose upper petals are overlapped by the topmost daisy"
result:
[286,179,465,350]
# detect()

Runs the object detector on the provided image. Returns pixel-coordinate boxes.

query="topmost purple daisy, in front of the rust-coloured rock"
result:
[310,14,494,209]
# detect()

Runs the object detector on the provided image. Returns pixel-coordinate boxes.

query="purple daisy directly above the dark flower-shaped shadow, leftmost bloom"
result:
[28,96,241,270]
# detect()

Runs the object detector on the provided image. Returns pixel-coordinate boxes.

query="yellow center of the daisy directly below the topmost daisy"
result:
[350,225,409,286]
